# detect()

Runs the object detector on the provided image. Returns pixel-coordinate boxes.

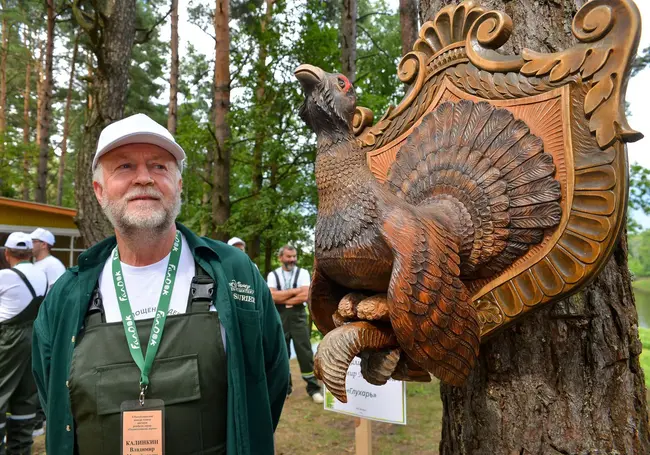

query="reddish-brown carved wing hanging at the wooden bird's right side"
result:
[383,209,480,385]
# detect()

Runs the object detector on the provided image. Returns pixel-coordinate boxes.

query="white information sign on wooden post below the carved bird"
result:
[324,357,406,425]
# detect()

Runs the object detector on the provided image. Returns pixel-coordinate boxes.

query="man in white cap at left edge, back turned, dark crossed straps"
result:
[0,232,47,454]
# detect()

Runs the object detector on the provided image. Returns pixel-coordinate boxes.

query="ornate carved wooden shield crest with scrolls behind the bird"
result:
[353,0,642,338]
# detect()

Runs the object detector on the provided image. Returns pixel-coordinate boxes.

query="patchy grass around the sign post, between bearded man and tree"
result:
[275,360,442,455]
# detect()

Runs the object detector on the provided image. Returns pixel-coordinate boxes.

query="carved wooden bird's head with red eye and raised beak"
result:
[294,65,357,138]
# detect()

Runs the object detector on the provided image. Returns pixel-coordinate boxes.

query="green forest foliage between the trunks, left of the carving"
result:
[0,0,402,273]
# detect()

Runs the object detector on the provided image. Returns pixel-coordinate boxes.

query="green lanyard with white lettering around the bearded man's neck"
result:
[113,231,181,405]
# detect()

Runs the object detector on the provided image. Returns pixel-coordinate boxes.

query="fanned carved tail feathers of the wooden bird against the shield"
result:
[388,100,561,279]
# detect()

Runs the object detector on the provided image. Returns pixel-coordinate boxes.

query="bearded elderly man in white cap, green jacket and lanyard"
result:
[34,114,289,455]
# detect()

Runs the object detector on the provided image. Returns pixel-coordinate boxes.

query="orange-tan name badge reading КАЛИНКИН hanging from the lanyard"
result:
[120,399,165,455]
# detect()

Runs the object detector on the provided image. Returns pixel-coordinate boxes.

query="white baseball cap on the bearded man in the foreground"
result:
[92,114,186,171]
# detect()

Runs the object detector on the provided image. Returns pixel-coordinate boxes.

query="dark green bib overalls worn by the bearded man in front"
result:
[68,284,228,455]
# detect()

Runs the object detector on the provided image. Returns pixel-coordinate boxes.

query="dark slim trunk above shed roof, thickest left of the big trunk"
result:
[34,0,54,204]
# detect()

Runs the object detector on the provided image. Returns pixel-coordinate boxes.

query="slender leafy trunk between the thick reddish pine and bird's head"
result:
[248,0,275,261]
